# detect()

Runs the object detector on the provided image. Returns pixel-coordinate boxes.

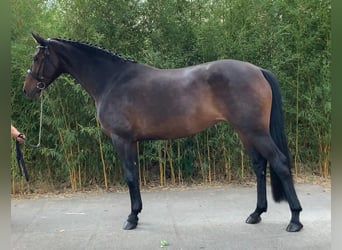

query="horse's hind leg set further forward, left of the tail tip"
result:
[246,149,267,224]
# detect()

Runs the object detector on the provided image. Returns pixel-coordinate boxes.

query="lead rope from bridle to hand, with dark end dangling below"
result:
[15,92,43,182]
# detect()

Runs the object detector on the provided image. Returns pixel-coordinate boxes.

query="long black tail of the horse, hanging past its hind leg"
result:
[261,69,291,202]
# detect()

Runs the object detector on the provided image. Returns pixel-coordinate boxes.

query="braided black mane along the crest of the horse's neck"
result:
[52,38,136,63]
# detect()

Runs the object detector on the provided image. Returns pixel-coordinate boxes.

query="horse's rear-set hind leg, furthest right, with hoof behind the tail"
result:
[253,135,303,232]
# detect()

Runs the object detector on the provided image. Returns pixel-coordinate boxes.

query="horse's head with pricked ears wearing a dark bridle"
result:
[23,34,61,97]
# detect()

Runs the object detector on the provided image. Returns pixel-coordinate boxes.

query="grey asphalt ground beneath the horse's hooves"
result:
[11,184,331,250]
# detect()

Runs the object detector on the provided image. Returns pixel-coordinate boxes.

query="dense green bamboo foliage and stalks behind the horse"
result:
[11,0,331,193]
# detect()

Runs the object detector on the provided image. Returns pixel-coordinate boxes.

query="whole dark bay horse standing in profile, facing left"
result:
[23,34,303,232]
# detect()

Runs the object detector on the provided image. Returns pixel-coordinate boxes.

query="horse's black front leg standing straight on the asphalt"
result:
[112,135,142,230]
